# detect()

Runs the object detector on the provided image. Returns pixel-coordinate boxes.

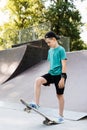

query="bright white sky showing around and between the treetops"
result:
[0,0,87,43]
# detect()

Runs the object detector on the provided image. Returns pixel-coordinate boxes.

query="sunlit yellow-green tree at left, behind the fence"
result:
[0,0,45,48]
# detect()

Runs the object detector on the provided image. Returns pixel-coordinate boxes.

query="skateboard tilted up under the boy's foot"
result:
[20,99,59,125]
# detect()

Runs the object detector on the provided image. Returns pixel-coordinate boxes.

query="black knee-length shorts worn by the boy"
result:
[41,73,65,95]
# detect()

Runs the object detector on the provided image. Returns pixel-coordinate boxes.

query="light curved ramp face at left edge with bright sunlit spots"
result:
[0,46,26,84]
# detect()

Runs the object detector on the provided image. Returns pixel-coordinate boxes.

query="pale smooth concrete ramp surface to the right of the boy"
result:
[65,51,87,112]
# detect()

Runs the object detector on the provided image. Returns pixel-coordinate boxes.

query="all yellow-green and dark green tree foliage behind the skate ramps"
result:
[0,0,86,51]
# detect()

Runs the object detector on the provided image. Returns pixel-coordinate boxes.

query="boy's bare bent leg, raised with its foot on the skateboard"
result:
[34,77,47,105]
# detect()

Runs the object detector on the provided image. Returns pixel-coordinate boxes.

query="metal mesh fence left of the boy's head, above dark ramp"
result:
[18,22,51,43]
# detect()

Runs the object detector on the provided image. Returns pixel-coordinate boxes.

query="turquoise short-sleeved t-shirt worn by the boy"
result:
[48,46,66,75]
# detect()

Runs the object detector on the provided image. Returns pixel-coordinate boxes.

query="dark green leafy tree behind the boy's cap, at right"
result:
[46,0,84,50]
